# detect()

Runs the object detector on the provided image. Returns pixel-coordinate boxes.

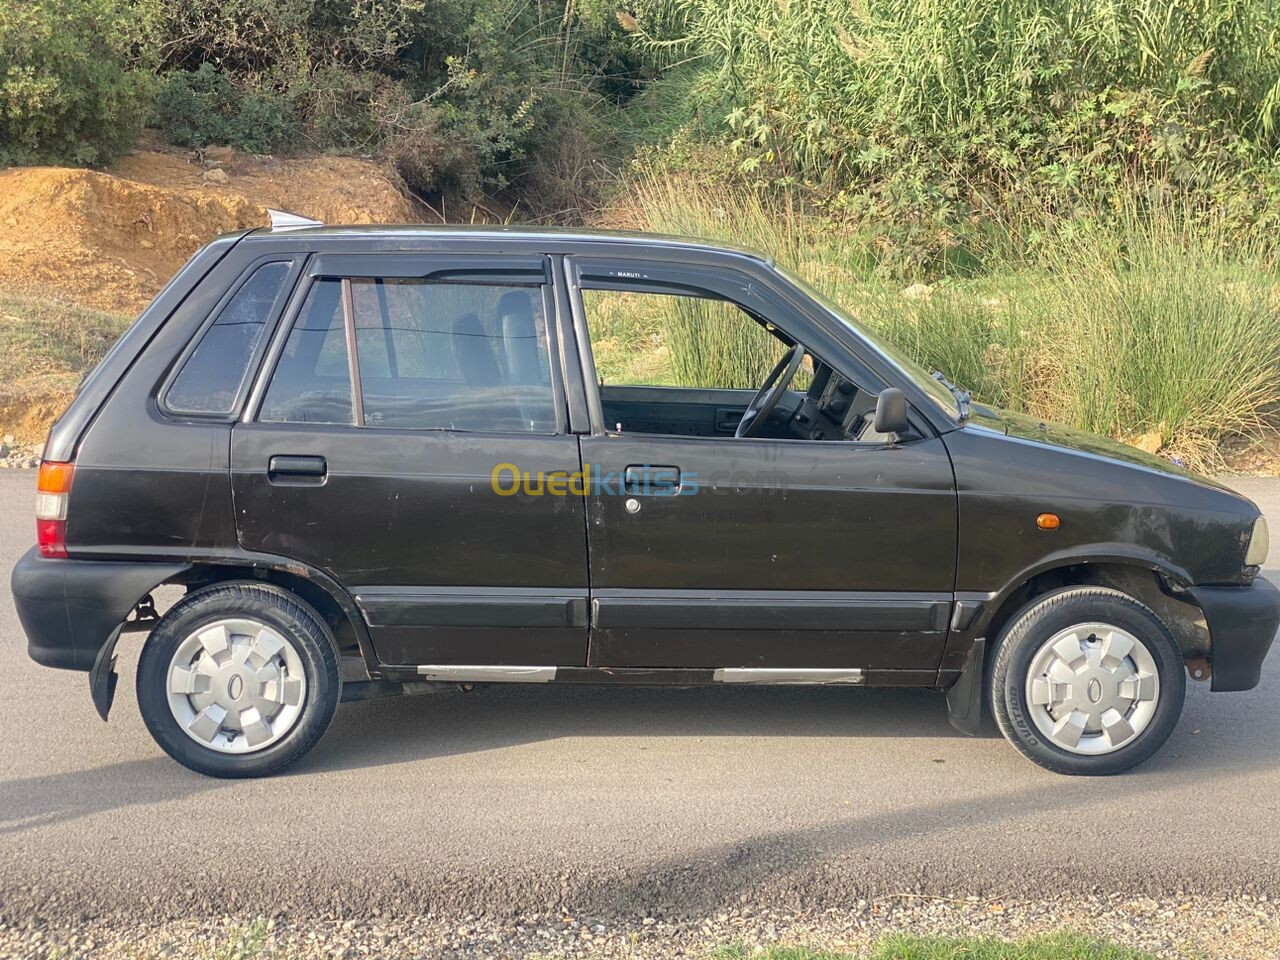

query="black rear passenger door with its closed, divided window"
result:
[232,255,586,667]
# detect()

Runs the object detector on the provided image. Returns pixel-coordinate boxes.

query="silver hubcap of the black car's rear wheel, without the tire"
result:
[168,620,307,754]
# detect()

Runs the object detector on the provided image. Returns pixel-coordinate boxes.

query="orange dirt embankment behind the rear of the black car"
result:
[0,145,421,443]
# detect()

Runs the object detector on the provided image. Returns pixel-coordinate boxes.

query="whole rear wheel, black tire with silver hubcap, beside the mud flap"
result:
[137,581,342,777]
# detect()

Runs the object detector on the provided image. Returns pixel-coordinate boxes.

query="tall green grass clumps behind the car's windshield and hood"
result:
[611,178,1280,468]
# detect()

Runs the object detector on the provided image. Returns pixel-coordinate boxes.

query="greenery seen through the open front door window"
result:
[582,289,786,390]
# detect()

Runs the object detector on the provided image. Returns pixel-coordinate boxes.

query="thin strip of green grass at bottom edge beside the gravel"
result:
[714,933,1167,960]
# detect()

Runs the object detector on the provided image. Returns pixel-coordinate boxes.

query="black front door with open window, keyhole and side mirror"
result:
[566,252,956,684]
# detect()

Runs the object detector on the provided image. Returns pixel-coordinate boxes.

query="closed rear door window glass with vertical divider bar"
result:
[262,279,556,434]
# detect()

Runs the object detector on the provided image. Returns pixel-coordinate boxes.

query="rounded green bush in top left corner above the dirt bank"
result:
[0,0,154,166]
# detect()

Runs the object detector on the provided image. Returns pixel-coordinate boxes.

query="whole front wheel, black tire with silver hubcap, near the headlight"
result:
[989,586,1187,776]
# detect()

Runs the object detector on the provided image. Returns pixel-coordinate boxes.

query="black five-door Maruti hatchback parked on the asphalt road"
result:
[13,218,1280,777]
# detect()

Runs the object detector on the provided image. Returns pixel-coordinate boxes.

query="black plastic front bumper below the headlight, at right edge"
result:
[1190,577,1280,690]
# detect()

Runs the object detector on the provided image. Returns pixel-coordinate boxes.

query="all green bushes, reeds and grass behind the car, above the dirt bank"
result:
[0,0,1280,466]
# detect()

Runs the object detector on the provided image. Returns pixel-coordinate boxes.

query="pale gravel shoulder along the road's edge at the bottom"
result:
[0,895,1280,960]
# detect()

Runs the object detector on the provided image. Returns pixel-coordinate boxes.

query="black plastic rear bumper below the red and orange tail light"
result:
[9,547,187,671]
